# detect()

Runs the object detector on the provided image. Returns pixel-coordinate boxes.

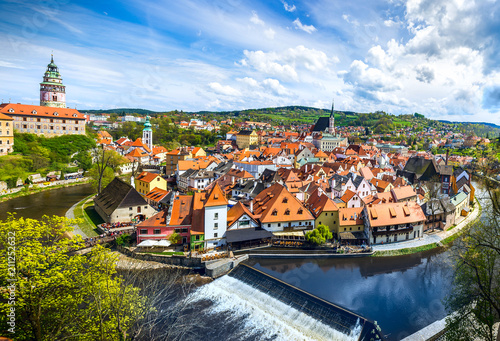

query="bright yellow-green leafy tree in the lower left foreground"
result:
[0,216,145,340]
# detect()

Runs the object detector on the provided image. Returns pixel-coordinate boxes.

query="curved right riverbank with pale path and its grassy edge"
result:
[372,198,482,257]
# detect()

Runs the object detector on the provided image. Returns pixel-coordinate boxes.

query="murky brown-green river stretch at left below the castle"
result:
[0,184,93,220]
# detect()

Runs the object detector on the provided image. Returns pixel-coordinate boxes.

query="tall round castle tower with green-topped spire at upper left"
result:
[40,55,66,108]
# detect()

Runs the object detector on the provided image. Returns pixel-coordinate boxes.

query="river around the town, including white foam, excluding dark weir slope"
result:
[0,179,486,340]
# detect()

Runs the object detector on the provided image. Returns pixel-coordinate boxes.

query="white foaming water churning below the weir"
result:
[186,276,362,341]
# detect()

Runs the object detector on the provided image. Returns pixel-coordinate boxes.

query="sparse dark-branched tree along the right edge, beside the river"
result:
[446,160,500,341]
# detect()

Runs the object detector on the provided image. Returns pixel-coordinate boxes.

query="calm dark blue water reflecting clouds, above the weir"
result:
[251,250,452,340]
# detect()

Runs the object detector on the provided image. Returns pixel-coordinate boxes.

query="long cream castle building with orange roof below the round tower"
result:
[0,103,85,137]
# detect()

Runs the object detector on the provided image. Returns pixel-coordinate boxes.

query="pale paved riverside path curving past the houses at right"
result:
[372,200,479,251]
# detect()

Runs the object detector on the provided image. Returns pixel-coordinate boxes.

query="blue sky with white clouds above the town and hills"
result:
[0,0,500,124]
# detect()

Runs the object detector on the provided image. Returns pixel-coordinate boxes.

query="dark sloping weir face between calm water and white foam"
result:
[228,264,385,341]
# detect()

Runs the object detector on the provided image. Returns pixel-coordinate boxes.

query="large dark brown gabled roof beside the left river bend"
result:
[94,178,148,216]
